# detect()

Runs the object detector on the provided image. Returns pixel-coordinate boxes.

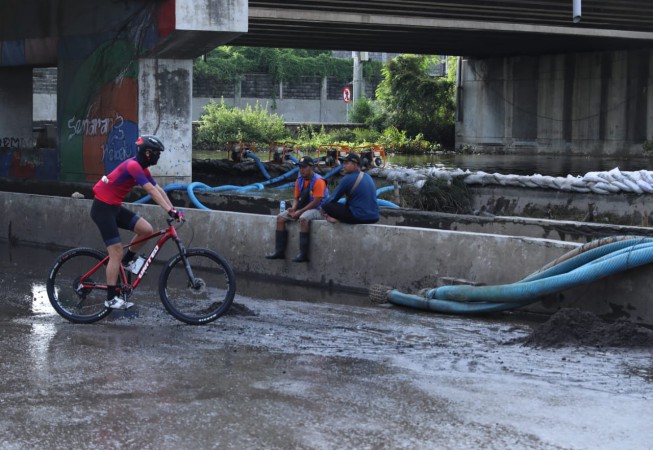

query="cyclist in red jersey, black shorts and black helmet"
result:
[91,135,183,309]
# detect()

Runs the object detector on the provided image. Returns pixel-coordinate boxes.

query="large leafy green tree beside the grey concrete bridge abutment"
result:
[376,55,455,148]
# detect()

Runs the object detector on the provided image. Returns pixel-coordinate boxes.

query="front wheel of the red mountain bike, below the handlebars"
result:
[159,248,236,325]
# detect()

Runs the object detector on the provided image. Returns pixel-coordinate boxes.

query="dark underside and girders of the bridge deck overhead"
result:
[232,0,653,57]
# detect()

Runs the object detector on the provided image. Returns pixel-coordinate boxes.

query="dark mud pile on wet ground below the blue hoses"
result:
[512,308,653,348]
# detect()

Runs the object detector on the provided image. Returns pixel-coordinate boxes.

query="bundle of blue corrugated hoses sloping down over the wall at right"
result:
[370,236,653,314]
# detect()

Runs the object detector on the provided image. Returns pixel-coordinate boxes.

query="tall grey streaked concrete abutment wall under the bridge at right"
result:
[456,49,653,156]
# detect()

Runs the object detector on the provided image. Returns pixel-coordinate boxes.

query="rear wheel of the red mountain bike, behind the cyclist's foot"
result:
[47,248,111,323]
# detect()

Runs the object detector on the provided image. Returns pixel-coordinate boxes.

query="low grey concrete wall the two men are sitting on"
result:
[0,192,653,324]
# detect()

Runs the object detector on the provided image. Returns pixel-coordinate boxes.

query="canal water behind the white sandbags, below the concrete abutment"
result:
[193,152,653,177]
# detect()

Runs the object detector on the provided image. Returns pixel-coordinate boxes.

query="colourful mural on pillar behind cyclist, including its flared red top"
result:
[57,0,175,181]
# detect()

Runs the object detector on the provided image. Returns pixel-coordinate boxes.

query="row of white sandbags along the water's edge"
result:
[370,167,653,195]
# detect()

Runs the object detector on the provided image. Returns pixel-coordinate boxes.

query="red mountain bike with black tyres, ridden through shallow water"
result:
[47,219,236,325]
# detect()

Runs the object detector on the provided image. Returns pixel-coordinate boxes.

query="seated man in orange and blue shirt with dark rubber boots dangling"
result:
[265,156,329,262]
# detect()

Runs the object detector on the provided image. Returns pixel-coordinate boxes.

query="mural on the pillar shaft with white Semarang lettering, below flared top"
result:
[58,41,138,181]
